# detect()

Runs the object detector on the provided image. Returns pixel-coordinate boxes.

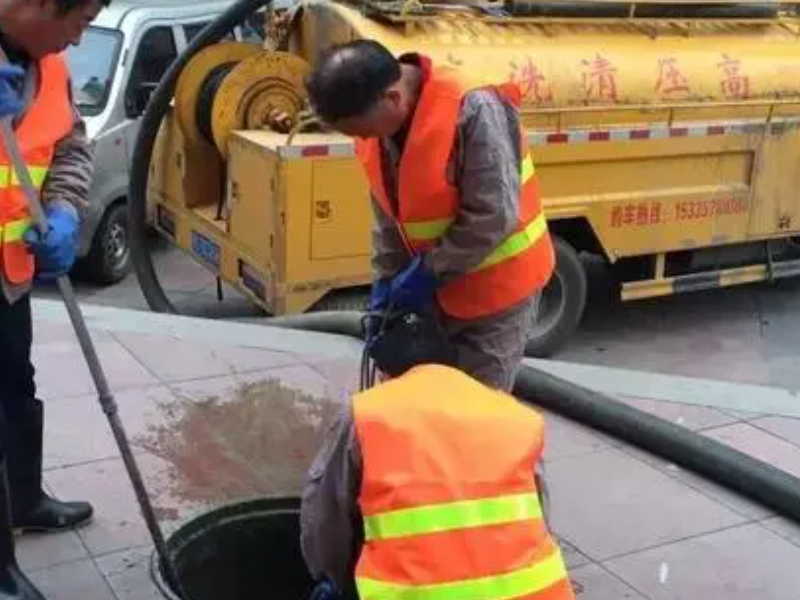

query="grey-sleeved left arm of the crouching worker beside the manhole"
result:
[300,404,364,592]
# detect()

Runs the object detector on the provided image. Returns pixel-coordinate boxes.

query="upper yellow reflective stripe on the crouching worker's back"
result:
[364,493,542,541]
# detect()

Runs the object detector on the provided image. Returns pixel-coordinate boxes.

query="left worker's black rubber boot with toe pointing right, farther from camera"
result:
[8,400,93,532]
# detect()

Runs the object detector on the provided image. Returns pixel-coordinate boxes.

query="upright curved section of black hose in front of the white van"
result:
[128,0,272,313]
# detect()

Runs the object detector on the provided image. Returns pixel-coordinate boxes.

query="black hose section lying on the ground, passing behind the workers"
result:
[258,312,800,523]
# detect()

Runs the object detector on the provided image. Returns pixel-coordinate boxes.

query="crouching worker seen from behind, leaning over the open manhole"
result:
[300,315,574,600]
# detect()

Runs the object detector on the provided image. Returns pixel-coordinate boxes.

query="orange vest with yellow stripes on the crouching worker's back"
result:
[353,365,574,600]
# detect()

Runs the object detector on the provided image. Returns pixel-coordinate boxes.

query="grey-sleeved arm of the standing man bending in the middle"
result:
[426,89,520,282]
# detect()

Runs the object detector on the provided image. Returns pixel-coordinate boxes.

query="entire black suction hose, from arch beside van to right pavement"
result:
[128,0,800,522]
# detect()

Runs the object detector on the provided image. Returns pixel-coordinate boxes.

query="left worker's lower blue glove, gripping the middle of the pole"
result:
[24,204,78,281]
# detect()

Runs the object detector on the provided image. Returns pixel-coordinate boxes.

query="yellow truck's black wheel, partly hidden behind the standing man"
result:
[525,236,586,358]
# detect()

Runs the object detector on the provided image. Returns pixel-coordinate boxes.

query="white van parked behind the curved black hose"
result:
[67,0,263,284]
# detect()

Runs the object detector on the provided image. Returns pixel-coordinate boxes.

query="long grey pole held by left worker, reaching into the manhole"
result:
[0,110,186,599]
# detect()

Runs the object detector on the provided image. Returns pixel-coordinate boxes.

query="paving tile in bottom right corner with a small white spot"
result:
[604,523,800,600]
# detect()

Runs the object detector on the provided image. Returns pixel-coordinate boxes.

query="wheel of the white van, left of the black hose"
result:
[78,203,131,285]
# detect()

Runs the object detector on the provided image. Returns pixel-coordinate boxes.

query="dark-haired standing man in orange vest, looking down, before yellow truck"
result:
[307,40,554,391]
